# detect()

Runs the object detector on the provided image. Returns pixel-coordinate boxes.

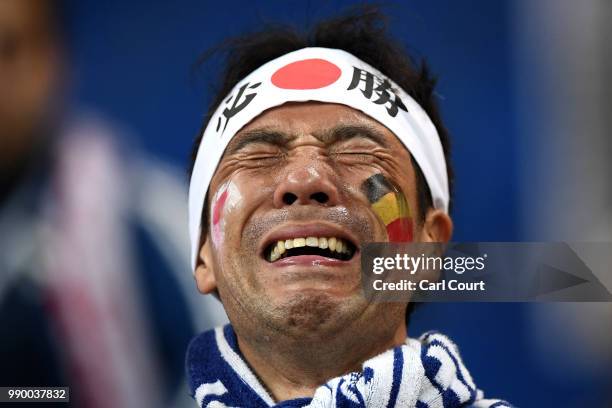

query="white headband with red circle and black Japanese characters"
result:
[189,48,449,269]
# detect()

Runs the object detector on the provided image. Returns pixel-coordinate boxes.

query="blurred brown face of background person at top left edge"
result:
[0,0,62,167]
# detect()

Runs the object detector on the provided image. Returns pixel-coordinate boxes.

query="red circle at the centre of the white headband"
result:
[271,58,342,89]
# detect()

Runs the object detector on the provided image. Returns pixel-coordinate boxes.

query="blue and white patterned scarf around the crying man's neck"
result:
[186,325,512,408]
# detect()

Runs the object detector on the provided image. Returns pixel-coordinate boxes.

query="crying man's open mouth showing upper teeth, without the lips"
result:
[264,237,356,262]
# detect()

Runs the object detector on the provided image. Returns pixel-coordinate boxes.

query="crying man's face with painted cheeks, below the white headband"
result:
[196,102,450,339]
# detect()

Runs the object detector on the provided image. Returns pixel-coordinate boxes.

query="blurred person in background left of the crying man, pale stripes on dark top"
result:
[0,0,223,407]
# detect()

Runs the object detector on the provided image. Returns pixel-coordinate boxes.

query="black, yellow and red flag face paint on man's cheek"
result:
[361,174,412,242]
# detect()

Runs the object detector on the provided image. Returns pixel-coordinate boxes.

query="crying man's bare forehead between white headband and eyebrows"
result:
[237,102,397,140]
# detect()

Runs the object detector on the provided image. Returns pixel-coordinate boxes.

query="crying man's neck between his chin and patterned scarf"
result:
[236,324,406,401]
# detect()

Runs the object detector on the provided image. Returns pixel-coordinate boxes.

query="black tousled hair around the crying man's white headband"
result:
[189,5,453,222]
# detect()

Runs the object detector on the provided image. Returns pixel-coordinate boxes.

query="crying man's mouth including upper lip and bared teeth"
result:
[262,225,357,263]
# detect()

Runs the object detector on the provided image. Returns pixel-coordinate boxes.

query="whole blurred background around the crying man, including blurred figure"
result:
[0,0,612,407]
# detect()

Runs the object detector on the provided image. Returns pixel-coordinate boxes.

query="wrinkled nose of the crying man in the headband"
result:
[274,158,339,208]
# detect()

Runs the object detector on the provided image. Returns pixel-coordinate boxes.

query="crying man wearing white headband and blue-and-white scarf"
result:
[187,9,509,407]
